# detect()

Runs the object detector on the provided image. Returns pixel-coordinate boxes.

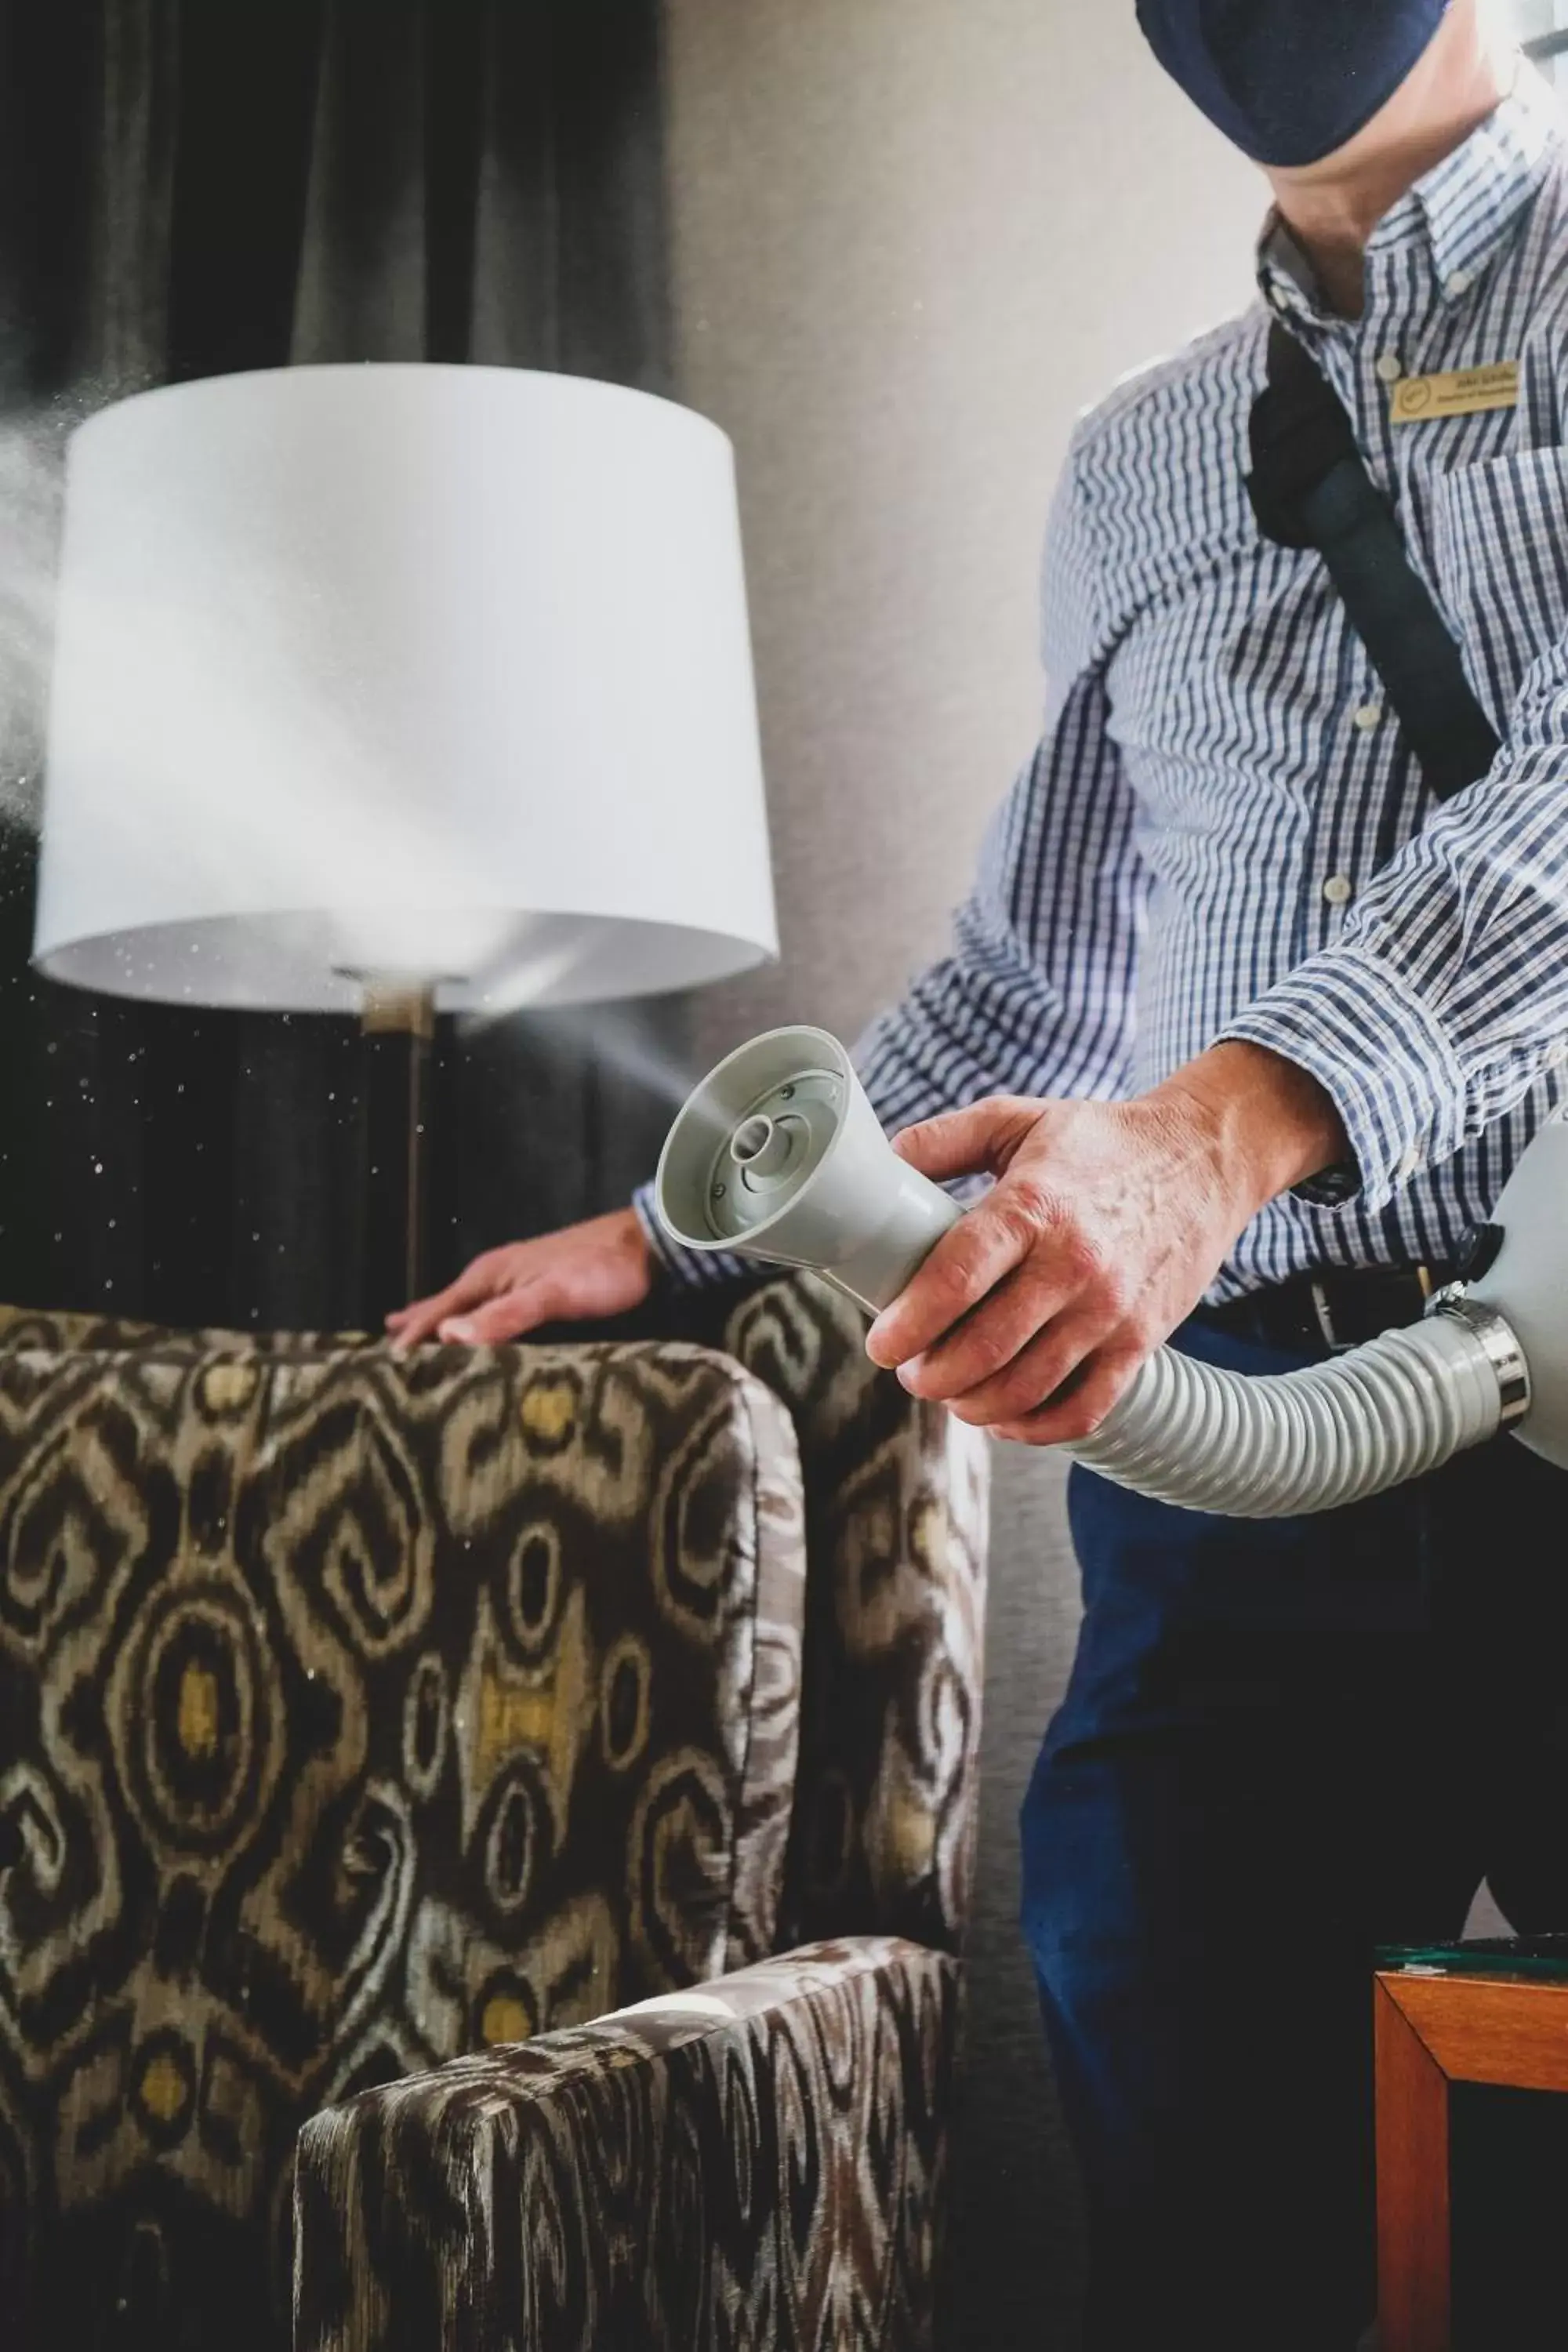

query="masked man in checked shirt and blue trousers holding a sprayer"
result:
[393,0,1568,2352]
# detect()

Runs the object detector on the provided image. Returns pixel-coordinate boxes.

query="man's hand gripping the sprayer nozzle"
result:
[867,1044,1347,1446]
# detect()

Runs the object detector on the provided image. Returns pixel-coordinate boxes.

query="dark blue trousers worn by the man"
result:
[1022,1317,1568,2352]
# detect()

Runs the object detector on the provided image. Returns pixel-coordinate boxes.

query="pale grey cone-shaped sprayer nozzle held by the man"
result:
[654,1028,964,1312]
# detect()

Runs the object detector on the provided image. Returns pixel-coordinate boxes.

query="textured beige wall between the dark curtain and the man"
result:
[666,0,1260,1049]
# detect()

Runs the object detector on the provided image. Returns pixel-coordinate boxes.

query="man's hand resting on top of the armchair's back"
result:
[386,1209,654,1348]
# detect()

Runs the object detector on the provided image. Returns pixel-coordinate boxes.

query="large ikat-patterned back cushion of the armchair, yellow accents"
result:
[0,1317,804,2352]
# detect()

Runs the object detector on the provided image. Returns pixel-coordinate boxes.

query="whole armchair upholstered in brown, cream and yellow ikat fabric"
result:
[0,1282,985,2352]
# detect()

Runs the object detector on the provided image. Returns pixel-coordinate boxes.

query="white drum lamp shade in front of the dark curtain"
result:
[35,367,776,1011]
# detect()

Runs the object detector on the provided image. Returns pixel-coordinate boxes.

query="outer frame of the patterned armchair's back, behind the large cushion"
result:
[0,1275,989,1950]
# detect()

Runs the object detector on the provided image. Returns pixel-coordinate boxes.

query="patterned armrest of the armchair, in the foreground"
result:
[294,1938,959,2352]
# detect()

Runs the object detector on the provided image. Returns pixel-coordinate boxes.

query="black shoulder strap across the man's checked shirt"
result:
[1246,322,1497,800]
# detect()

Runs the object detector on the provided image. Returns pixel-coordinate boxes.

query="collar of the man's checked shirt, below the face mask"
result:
[1258,59,1561,320]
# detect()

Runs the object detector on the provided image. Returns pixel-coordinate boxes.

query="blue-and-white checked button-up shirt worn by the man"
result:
[644,68,1568,1298]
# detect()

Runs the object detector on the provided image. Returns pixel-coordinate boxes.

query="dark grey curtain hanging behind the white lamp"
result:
[0,0,680,1327]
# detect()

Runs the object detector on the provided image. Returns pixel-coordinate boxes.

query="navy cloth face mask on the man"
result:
[1138,0,1448,165]
